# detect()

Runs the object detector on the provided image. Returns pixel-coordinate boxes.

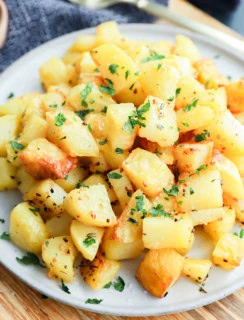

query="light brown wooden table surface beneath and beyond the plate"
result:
[0,0,244,320]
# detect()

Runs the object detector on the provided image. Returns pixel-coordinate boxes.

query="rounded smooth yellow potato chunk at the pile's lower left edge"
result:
[9,202,48,254]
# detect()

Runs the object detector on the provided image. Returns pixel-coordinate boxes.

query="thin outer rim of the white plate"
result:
[0,23,244,317]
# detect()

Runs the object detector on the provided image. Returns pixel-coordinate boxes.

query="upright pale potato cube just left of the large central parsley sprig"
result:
[105,103,138,150]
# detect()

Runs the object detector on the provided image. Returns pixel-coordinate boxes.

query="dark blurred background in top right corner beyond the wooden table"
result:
[189,0,244,35]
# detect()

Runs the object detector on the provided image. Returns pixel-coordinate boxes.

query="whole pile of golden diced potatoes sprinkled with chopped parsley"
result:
[0,21,244,297]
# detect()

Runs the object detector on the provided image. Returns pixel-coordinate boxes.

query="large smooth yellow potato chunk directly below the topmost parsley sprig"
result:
[139,60,179,100]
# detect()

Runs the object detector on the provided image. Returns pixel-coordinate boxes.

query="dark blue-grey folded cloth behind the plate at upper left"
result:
[0,0,168,72]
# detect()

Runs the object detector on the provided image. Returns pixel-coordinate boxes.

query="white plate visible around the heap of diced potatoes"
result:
[0,24,244,316]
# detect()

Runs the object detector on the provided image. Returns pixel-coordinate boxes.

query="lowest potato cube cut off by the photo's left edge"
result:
[0,157,17,191]
